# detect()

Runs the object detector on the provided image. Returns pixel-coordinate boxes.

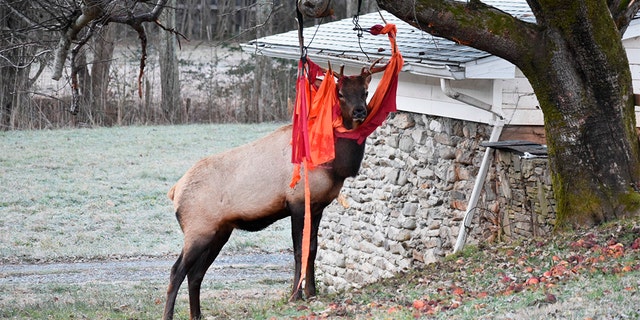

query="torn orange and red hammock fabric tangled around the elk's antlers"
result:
[291,24,403,287]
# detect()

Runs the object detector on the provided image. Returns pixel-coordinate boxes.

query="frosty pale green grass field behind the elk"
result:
[0,124,290,263]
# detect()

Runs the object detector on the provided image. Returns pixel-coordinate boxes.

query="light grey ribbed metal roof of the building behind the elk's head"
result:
[243,0,535,78]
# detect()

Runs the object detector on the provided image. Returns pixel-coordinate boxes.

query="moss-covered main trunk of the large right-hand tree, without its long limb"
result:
[521,2,640,227]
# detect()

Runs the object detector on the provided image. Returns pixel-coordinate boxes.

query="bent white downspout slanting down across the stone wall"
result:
[440,79,504,253]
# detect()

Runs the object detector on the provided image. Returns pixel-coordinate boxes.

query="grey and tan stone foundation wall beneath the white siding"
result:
[316,112,554,292]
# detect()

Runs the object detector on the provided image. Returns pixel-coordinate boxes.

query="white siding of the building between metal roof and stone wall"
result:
[345,37,640,126]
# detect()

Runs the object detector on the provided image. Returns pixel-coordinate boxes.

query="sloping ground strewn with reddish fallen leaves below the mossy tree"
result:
[272,218,640,319]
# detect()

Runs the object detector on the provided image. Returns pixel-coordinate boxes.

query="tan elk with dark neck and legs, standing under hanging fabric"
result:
[163,63,381,319]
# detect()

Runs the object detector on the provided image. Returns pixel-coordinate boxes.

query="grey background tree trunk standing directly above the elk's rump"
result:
[158,0,182,123]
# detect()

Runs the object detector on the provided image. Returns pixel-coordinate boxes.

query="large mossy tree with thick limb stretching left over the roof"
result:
[377,0,640,228]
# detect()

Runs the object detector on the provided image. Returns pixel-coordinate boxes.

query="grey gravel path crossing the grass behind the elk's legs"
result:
[0,253,293,285]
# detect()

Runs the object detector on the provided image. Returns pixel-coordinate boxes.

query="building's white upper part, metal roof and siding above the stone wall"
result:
[243,0,640,143]
